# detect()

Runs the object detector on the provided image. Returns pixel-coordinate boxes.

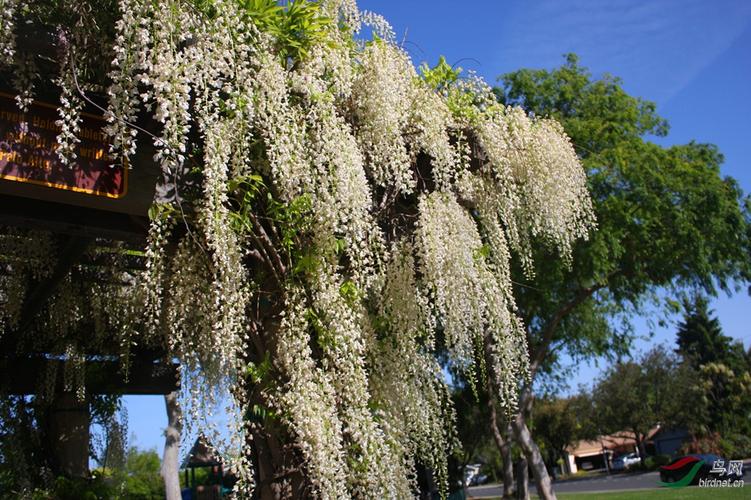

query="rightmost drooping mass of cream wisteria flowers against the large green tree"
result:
[472,105,594,271]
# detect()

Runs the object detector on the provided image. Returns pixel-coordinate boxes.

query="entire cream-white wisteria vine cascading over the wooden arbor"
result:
[0,0,594,498]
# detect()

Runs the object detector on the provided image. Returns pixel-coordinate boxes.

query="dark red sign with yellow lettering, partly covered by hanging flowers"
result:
[0,92,128,199]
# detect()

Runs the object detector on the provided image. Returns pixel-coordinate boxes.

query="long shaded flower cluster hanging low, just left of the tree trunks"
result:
[368,240,455,490]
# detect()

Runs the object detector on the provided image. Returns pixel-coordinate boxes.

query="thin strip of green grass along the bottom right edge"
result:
[524,487,751,500]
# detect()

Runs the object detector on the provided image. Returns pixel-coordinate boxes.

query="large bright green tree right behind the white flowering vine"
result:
[488,55,751,498]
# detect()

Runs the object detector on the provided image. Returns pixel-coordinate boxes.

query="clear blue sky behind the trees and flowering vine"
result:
[126,0,751,453]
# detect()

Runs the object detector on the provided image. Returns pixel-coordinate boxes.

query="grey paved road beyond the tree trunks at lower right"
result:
[467,470,751,498]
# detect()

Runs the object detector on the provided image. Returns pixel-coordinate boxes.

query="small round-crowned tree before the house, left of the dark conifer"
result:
[592,347,700,465]
